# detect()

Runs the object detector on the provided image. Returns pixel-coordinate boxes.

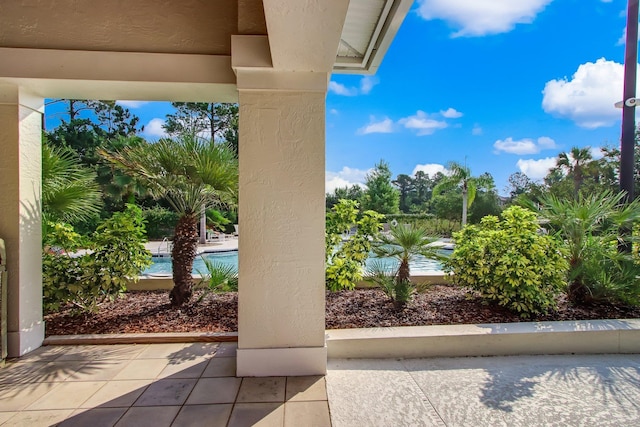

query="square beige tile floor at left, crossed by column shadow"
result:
[0,343,331,427]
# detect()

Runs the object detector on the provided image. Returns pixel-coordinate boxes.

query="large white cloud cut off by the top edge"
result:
[418,0,553,37]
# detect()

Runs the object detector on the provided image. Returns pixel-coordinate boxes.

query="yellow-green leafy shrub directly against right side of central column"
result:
[325,199,383,291]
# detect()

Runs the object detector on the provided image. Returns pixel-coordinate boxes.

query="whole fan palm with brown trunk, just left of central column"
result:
[101,135,238,306]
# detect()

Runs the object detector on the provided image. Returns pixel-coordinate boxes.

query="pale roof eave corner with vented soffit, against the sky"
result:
[333,0,413,74]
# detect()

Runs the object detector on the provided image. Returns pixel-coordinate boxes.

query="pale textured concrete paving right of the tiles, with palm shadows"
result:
[326,354,640,427]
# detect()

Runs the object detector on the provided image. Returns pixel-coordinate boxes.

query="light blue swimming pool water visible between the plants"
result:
[142,251,442,275]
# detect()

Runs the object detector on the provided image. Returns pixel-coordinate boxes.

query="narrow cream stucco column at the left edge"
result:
[0,85,44,357]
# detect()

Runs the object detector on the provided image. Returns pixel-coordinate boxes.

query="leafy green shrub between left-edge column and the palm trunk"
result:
[42,205,151,312]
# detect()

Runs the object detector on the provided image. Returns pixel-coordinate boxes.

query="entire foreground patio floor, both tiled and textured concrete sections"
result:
[0,343,640,427]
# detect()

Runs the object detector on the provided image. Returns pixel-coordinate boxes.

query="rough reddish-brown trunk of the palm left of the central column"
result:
[169,214,198,307]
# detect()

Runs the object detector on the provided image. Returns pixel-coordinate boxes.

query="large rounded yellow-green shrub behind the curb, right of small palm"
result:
[445,206,568,317]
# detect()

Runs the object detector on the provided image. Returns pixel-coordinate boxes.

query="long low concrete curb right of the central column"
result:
[327,319,640,359]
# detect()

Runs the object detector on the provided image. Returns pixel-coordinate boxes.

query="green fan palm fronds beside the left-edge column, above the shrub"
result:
[42,139,102,224]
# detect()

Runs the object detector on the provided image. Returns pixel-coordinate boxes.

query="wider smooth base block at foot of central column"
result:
[236,345,327,377]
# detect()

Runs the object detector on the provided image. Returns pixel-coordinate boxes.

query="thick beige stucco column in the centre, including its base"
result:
[237,73,327,376]
